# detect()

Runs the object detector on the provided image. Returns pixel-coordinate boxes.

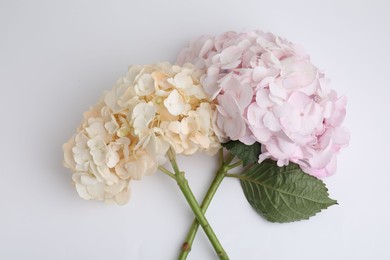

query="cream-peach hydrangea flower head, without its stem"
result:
[63,63,220,204]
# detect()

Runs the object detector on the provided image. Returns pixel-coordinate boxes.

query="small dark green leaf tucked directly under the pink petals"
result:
[222,141,261,166]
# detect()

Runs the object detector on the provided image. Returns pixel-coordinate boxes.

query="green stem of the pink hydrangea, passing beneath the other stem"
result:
[178,149,235,260]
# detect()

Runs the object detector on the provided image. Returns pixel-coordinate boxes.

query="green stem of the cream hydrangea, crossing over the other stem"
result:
[168,150,229,260]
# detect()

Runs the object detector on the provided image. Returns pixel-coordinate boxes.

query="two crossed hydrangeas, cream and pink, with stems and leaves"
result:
[63,31,349,259]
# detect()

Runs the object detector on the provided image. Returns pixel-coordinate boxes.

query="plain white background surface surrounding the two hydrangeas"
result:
[0,0,390,260]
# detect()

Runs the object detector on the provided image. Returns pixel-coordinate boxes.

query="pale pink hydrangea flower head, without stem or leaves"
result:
[177,31,349,178]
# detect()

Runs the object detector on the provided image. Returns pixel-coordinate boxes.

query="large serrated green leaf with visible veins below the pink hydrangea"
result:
[236,160,337,223]
